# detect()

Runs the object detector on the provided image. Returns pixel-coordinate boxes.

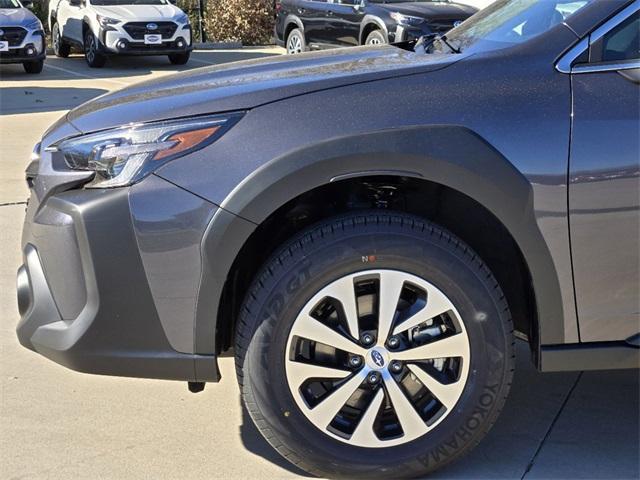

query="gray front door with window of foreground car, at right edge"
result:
[569,8,640,342]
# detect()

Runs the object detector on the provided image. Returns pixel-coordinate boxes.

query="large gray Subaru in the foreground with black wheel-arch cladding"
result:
[17,0,640,479]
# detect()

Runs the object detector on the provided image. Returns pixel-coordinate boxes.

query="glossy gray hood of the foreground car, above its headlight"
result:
[67,45,465,132]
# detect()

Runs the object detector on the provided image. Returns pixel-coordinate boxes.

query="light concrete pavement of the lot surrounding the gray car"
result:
[0,48,640,479]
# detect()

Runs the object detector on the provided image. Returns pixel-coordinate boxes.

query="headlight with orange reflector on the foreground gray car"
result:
[47,114,242,188]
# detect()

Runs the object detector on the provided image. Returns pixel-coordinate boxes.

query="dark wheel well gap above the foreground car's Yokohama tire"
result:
[216,176,538,352]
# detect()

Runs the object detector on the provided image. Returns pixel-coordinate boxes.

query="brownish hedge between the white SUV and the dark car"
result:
[205,0,275,45]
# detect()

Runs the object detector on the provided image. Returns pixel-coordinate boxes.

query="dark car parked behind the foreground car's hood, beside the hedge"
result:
[275,0,477,53]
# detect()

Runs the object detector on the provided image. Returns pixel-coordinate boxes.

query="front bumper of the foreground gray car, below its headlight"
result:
[17,172,219,382]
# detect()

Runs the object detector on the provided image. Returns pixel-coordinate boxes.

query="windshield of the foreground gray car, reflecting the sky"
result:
[430,0,595,53]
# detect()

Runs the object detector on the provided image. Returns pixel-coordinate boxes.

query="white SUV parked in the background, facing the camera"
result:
[49,0,193,68]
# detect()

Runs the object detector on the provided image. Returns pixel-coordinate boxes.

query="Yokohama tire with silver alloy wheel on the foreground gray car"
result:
[236,212,514,479]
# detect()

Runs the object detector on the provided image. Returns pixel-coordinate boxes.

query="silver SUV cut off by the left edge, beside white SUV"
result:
[0,0,46,73]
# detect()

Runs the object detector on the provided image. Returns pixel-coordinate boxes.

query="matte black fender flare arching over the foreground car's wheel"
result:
[195,125,565,354]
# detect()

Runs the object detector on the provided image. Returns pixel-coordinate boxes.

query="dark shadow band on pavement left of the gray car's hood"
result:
[0,85,107,115]
